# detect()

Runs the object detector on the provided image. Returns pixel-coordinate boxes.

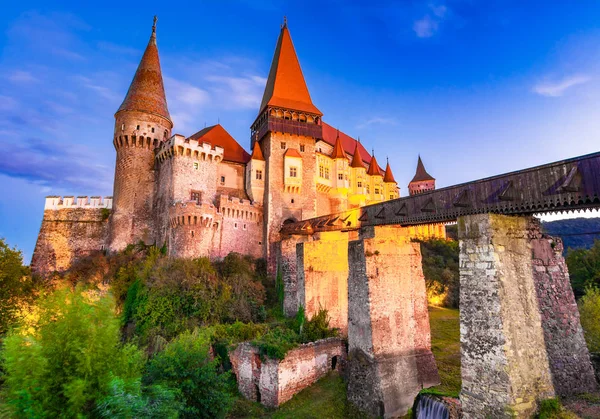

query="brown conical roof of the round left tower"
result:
[117,16,173,125]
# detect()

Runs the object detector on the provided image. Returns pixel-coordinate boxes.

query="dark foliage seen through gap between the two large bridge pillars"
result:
[420,239,460,308]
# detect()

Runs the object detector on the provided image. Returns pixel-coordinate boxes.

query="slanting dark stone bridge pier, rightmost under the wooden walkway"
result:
[529,219,597,396]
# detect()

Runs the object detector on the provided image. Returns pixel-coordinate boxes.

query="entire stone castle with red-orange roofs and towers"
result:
[31,19,435,275]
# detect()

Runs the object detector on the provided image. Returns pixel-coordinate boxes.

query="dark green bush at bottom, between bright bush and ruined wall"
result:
[145,329,233,418]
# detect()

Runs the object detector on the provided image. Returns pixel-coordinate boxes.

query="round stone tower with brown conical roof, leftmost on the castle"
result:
[109,17,173,251]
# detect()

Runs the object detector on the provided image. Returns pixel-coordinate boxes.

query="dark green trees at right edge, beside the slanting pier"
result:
[566,240,600,299]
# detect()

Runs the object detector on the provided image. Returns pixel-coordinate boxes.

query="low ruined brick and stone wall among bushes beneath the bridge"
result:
[229,338,346,407]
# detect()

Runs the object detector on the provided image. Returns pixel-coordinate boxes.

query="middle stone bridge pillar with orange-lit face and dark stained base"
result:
[348,226,440,418]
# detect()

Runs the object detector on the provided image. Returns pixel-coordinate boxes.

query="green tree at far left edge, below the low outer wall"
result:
[0,238,33,335]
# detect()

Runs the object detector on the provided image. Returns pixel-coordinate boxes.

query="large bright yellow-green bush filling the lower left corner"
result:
[2,288,143,417]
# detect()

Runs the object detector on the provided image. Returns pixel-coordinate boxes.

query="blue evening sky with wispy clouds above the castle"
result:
[0,0,600,263]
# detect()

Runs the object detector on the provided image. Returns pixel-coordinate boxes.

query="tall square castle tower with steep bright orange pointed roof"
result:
[252,22,323,271]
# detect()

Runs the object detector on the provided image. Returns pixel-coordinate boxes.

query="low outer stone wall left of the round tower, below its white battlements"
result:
[31,208,109,276]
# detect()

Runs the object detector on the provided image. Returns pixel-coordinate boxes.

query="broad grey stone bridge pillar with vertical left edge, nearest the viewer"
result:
[458,214,554,418]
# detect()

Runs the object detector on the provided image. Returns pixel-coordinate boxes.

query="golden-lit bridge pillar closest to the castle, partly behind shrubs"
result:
[296,231,348,335]
